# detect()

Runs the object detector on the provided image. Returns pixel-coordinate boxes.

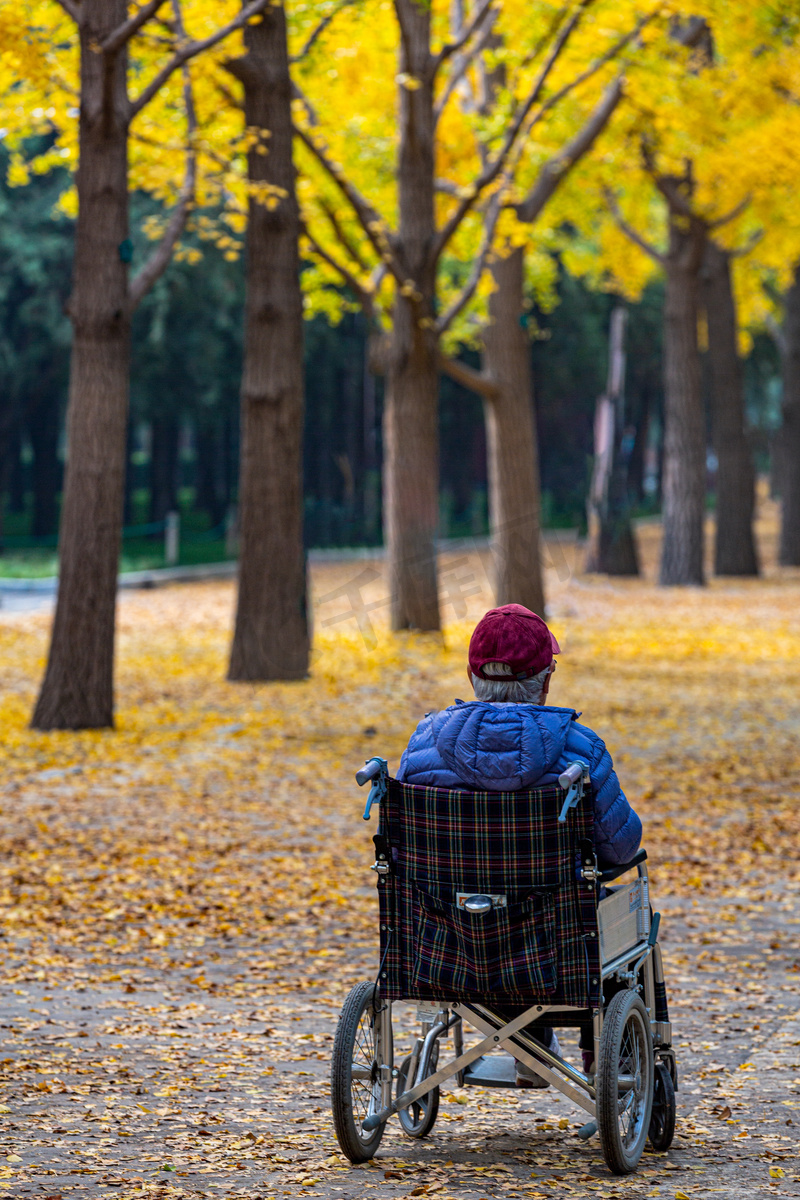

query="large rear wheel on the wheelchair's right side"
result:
[595,990,654,1175]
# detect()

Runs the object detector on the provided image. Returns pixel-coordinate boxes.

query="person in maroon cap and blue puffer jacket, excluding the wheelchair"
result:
[396,604,642,1087]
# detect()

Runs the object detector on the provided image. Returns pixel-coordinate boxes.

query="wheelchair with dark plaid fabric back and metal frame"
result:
[331,757,678,1175]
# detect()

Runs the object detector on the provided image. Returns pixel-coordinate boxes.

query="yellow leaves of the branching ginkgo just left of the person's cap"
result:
[294,0,662,348]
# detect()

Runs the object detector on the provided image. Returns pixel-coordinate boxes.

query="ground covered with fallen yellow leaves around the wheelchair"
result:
[0,513,800,1200]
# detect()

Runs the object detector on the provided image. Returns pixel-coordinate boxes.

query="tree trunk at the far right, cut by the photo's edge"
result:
[778,265,800,566]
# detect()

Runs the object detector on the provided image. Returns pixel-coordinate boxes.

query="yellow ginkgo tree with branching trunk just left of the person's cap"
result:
[295,0,645,629]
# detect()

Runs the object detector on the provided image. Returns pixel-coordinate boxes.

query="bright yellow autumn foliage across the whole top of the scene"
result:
[6,0,800,344]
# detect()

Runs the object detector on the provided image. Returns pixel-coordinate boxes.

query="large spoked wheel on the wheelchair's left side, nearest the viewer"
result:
[331,983,385,1163]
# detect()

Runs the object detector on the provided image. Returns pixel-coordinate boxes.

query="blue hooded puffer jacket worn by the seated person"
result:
[397,700,642,865]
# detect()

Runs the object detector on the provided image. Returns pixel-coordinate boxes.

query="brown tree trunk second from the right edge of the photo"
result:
[703,240,758,575]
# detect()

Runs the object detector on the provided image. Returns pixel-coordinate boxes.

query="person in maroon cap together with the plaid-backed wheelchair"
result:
[331,605,678,1175]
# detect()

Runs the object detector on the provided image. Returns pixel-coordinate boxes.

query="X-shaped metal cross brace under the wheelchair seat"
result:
[362,1003,595,1133]
